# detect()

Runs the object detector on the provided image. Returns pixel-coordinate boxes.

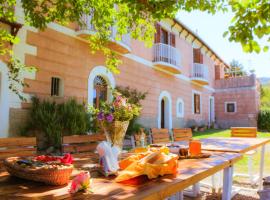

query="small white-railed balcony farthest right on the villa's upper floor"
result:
[191,63,209,85]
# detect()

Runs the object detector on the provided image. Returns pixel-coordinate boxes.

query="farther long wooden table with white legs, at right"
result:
[175,137,270,198]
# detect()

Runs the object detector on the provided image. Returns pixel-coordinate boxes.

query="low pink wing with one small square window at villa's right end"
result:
[214,74,260,128]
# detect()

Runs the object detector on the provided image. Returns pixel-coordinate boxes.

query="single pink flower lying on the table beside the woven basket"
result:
[69,172,91,194]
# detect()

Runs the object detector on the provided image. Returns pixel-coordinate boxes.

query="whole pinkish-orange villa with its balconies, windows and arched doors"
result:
[0,5,259,137]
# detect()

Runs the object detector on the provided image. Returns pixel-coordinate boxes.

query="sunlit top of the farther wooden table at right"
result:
[175,137,270,153]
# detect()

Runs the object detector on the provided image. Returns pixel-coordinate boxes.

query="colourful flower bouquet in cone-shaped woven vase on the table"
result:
[96,90,141,149]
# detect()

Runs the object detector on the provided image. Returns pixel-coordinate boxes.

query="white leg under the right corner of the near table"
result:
[222,166,233,200]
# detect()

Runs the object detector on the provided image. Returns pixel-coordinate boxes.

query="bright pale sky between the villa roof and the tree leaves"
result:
[177,11,270,77]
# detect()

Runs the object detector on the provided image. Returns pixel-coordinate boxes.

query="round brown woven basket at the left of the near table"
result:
[4,157,73,185]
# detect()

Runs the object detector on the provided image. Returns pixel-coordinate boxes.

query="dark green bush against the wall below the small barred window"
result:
[24,97,91,140]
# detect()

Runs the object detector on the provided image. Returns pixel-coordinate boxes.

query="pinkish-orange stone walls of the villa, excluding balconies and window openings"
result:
[0,10,258,136]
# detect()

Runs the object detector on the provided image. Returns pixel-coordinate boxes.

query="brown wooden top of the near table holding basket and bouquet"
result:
[0,152,242,200]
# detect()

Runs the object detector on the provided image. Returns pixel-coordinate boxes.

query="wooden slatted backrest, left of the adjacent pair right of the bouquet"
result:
[151,128,170,144]
